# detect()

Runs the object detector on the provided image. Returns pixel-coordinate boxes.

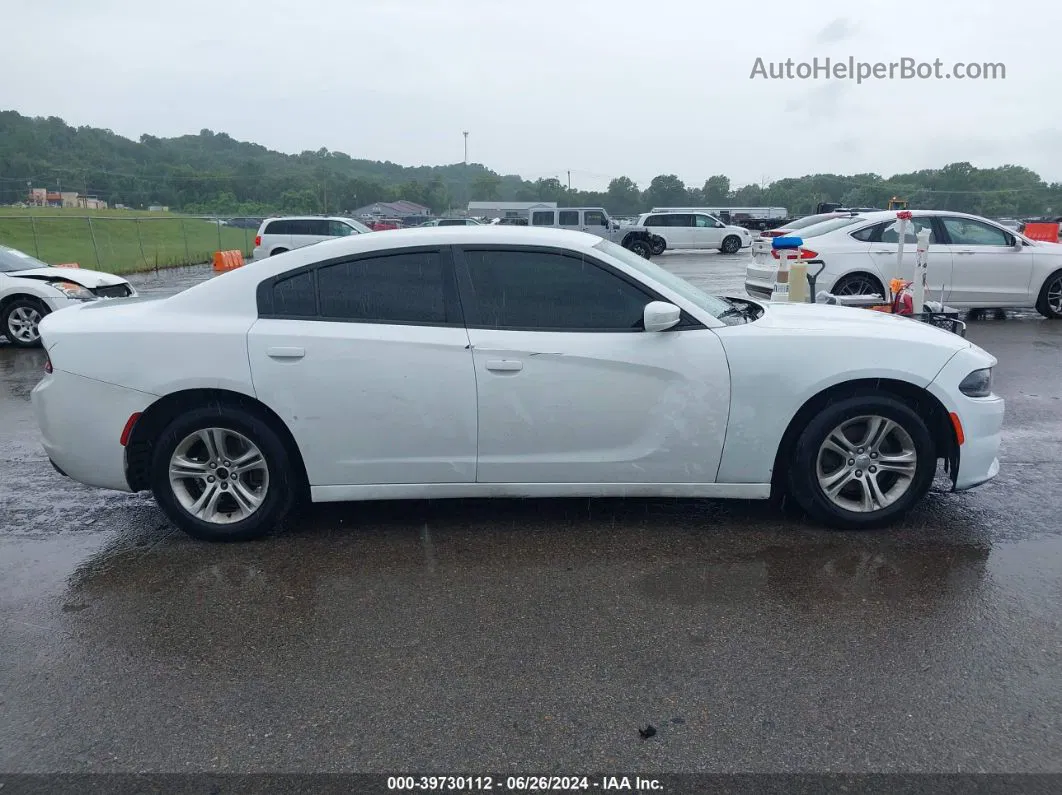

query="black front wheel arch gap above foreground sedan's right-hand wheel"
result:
[771,378,959,498]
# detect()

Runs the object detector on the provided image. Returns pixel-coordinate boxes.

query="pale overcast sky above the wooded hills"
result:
[0,0,1062,189]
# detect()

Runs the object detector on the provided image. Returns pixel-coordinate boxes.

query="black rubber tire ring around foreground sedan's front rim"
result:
[788,395,937,530]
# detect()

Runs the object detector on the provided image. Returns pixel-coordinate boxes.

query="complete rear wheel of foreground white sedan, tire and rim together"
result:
[151,403,299,541]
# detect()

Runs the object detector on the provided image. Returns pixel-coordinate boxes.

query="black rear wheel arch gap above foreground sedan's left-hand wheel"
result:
[125,388,309,492]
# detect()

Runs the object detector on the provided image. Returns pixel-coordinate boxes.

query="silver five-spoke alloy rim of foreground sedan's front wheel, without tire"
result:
[816,415,918,514]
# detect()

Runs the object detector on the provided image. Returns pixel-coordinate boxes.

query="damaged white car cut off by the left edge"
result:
[0,245,136,348]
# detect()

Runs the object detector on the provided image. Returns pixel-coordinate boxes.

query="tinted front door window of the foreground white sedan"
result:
[465,250,652,331]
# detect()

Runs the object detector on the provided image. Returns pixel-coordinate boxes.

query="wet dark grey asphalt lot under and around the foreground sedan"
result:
[0,255,1062,775]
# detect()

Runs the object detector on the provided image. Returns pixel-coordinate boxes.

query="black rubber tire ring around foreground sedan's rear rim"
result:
[151,405,297,541]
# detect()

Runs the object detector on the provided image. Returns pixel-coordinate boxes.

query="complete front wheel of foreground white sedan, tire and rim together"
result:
[789,393,937,530]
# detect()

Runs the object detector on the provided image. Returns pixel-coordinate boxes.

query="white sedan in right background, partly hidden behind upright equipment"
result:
[746,210,1062,318]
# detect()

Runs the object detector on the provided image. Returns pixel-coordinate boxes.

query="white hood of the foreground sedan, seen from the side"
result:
[746,299,971,355]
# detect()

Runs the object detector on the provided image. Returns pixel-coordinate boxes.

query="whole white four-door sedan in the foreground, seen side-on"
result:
[33,226,1004,540]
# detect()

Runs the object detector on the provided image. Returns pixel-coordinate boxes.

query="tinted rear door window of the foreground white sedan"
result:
[318,252,447,324]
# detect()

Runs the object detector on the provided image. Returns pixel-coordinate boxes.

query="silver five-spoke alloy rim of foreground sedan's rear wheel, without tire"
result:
[170,428,269,524]
